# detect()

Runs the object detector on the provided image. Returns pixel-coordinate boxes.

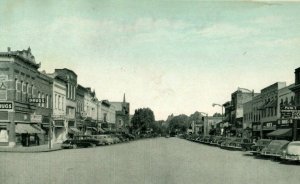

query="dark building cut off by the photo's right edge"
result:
[290,67,300,140]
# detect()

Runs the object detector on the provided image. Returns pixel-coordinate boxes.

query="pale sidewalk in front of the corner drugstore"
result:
[0,144,62,153]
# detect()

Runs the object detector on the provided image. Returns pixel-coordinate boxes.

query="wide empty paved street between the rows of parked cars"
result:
[0,138,300,184]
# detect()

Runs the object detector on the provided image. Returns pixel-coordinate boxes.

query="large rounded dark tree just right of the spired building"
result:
[131,108,155,132]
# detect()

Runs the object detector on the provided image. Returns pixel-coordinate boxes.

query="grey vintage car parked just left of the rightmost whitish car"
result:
[260,140,289,157]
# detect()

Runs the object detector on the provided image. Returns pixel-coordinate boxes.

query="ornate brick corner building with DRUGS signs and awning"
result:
[0,48,51,146]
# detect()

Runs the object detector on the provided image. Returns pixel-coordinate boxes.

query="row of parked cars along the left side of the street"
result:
[61,134,135,148]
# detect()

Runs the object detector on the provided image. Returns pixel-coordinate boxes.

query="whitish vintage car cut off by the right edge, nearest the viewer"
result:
[281,141,300,162]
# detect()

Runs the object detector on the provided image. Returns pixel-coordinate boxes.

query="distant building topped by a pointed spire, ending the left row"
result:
[111,94,131,131]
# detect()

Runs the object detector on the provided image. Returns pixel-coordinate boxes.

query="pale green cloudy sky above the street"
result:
[0,0,300,120]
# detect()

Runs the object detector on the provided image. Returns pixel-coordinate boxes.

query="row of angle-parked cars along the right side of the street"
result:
[181,135,300,162]
